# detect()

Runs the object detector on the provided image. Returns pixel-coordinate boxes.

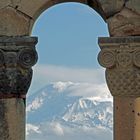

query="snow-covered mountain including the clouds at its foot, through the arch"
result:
[27,82,113,140]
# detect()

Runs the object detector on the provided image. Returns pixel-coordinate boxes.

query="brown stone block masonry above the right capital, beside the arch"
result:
[89,0,140,36]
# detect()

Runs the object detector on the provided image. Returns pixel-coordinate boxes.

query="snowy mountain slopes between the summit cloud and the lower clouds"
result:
[27,82,113,139]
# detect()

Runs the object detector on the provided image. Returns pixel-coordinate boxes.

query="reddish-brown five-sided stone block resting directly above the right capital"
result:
[107,8,140,36]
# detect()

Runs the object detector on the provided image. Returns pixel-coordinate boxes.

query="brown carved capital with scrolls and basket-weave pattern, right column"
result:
[98,37,140,97]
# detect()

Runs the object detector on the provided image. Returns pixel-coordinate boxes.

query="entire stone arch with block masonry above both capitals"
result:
[0,0,140,36]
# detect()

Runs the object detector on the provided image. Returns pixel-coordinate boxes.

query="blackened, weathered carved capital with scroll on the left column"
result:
[0,36,38,98]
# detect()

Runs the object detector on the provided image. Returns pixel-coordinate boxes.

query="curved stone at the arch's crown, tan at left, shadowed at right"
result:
[16,0,104,20]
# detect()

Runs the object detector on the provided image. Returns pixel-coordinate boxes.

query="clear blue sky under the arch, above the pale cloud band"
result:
[32,3,108,68]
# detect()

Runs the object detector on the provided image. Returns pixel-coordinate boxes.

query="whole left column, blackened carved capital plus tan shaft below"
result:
[0,36,37,140]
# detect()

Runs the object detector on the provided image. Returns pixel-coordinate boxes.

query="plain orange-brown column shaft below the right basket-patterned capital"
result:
[114,97,140,140]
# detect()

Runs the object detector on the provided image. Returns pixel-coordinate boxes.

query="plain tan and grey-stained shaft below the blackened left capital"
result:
[0,98,25,140]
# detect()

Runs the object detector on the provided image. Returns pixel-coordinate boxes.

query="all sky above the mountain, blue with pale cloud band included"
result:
[29,3,109,93]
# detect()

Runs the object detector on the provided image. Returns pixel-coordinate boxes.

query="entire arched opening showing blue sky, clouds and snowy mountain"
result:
[27,3,112,140]
